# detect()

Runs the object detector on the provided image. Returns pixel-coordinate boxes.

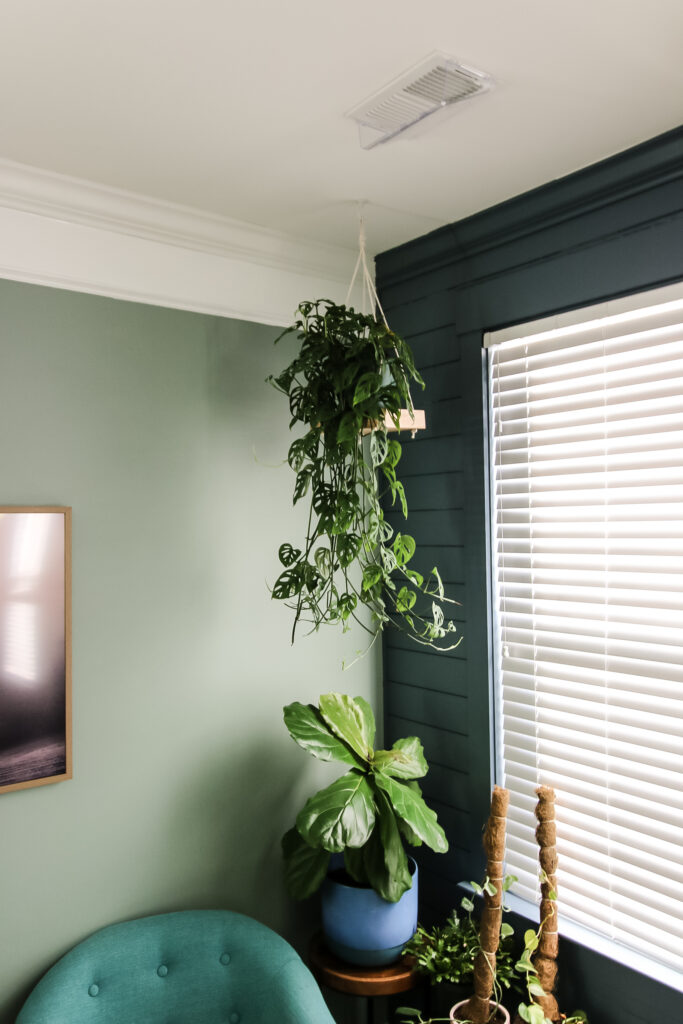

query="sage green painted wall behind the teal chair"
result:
[0,282,378,1024]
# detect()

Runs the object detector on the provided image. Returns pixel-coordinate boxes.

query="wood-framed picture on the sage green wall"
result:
[0,506,72,793]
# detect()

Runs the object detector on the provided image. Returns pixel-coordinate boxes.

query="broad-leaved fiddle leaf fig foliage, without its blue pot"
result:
[283,693,449,903]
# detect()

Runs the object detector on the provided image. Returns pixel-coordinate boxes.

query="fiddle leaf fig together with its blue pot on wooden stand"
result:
[283,693,449,964]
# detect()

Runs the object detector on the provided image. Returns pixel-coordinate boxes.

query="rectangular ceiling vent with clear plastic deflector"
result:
[347,53,494,150]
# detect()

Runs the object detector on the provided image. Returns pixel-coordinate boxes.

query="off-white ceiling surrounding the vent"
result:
[0,0,683,252]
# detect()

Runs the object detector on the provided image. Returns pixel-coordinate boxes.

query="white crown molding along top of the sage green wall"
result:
[0,160,362,324]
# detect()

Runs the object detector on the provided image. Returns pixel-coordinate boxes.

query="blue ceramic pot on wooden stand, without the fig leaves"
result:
[321,858,418,966]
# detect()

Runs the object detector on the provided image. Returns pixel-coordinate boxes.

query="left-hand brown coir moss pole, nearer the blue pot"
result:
[462,785,510,1024]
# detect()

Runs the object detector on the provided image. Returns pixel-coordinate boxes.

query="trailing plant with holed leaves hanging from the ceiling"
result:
[268,300,459,650]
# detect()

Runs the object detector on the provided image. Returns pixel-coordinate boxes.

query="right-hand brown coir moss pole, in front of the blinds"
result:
[531,785,560,1021]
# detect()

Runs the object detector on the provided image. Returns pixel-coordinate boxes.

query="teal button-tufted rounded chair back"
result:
[16,910,334,1024]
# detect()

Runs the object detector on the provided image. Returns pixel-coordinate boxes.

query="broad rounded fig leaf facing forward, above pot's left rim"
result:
[296,771,375,853]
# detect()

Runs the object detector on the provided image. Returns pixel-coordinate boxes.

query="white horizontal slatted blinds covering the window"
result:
[486,286,683,972]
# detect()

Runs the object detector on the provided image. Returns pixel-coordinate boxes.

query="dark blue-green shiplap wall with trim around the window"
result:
[377,129,683,1024]
